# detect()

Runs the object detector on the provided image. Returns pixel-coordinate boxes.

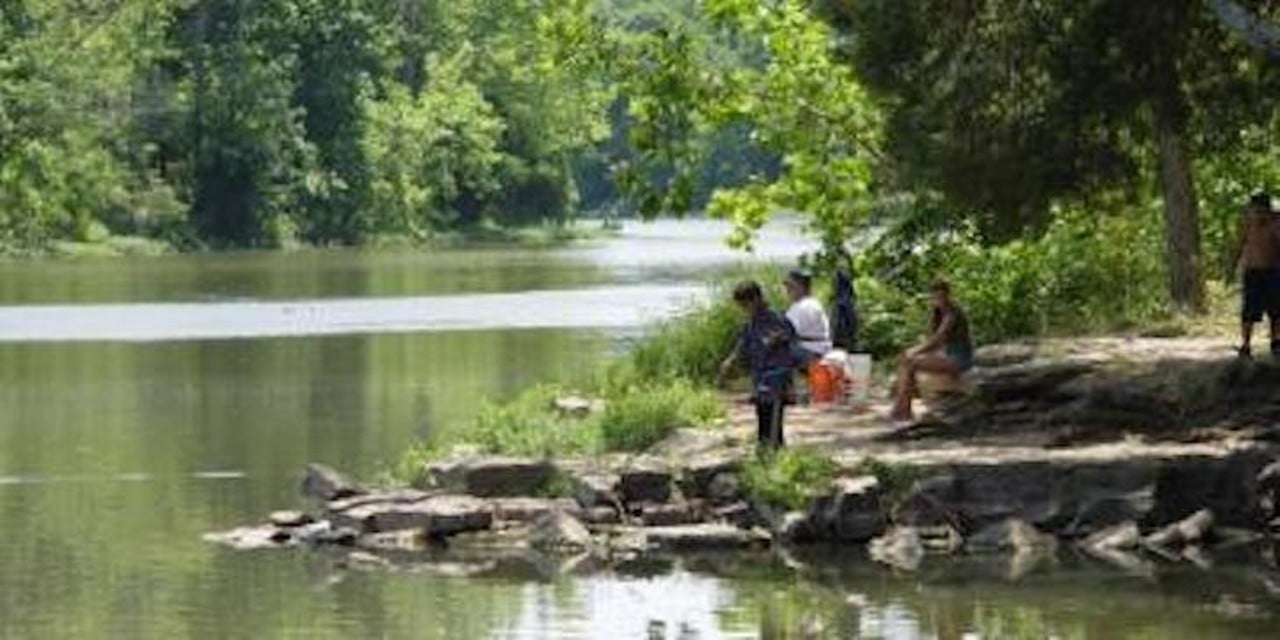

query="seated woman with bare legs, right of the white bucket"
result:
[888,280,973,422]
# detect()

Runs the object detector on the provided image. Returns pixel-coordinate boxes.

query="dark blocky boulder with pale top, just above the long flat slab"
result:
[421,458,556,498]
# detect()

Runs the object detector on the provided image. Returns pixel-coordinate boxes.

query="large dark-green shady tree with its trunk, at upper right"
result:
[820,0,1280,307]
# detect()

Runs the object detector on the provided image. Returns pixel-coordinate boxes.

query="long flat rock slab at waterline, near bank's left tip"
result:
[332,495,493,538]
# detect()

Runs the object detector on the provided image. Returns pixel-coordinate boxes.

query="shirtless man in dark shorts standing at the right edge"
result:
[1235,193,1280,358]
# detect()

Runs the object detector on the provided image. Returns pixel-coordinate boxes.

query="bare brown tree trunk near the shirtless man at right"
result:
[1156,96,1204,311]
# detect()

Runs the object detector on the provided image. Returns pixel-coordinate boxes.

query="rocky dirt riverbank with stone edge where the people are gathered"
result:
[211,339,1280,581]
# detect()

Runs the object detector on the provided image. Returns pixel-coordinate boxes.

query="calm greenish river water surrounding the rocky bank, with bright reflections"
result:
[0,221,1280,639]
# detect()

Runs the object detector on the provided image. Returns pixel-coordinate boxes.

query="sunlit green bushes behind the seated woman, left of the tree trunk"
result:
[858,206,1169,356]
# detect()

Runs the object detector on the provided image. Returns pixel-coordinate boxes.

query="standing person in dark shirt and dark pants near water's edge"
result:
[721,280,796,449]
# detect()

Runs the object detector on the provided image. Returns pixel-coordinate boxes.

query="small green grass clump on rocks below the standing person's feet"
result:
[742,448,836,509]
